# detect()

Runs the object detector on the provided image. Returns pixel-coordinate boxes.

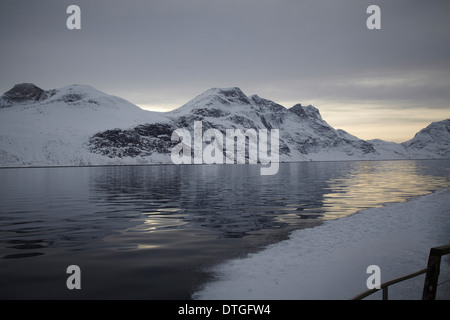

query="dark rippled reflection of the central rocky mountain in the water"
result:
[91,163,342,237]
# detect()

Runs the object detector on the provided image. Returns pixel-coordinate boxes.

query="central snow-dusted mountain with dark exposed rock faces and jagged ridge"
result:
[90,88,376,161]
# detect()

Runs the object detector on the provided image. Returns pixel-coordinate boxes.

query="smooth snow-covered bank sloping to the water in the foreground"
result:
[193,189,450,300]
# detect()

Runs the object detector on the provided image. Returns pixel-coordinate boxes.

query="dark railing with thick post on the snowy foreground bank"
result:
[352,245,450,300]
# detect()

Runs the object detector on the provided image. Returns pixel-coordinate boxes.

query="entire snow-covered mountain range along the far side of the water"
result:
[0,83,450,167]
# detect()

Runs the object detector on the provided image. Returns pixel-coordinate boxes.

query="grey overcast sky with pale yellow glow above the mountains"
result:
[0,0,450,142]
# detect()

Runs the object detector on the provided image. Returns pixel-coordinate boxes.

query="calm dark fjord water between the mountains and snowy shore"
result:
[0,160,450,299]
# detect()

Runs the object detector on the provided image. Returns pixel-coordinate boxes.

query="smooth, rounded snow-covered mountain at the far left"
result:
[0,83,169,166]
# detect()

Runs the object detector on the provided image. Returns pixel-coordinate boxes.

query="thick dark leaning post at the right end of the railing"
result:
[422,245,450,300]
